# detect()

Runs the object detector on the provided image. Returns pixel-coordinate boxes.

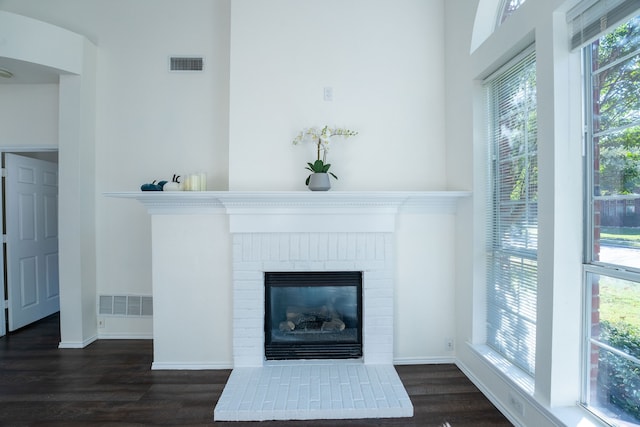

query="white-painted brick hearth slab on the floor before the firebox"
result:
[214,361,413,421]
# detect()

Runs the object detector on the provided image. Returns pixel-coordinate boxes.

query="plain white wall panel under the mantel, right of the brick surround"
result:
[394,213,458,364]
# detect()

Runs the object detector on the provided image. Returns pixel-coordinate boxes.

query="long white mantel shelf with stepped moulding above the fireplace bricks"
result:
[105,191,471,233]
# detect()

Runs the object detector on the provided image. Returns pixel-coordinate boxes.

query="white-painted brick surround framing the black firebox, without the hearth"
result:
[233,232,393,367]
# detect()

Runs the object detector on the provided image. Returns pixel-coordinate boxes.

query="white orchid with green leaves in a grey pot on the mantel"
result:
[293,125,358,191]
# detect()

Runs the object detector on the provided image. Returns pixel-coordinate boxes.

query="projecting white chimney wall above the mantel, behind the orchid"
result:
[229,0,446,190]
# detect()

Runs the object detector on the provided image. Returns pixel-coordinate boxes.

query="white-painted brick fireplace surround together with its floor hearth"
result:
[214,229,413,421]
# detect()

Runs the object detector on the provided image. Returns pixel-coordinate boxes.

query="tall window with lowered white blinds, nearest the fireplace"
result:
[485,49,538,374]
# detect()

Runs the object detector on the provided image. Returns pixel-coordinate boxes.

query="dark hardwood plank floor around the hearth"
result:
[0,315,511,427]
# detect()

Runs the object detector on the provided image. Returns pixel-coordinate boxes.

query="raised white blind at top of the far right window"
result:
[567,0,640,49]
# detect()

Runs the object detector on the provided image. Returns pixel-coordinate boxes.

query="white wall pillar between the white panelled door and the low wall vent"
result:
[58,39,97,348]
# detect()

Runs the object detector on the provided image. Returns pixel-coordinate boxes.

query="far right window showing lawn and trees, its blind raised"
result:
[575,10,640,425]
